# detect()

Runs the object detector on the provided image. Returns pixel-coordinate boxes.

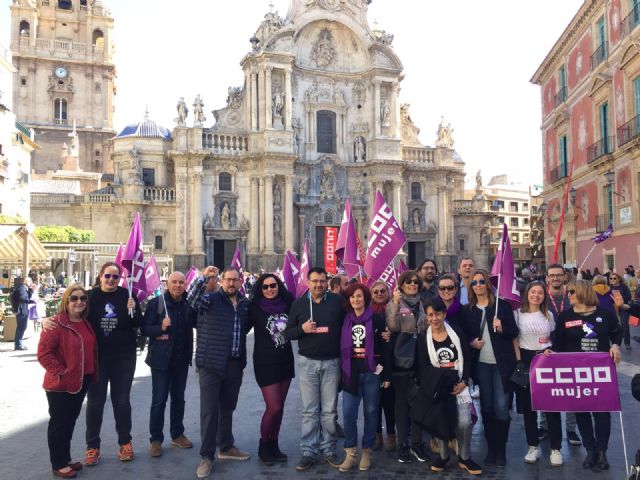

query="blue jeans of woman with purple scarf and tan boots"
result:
[342,372,380,448]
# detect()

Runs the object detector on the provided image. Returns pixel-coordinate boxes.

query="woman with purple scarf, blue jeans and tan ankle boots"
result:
[339,283,391,472]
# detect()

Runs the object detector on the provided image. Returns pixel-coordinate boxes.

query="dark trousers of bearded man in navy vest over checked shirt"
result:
[198,358,243,460]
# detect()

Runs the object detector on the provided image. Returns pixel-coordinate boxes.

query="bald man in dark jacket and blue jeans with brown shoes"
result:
[142,272,196,457]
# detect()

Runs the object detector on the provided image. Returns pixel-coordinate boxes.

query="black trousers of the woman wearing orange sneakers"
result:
[87,346,136,448]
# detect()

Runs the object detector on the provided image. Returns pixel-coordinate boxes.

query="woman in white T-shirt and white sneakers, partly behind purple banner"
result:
[515,281,563,467]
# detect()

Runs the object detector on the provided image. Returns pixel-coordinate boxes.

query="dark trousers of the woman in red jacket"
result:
[46,375,90,470]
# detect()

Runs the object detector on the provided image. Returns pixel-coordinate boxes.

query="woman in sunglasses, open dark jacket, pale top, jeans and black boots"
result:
[463,270,518,466]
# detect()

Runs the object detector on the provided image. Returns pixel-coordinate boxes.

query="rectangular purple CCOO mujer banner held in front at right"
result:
[529,352,620,412]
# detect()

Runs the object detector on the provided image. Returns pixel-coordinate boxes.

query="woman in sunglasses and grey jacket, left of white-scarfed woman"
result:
[387,270,429,463]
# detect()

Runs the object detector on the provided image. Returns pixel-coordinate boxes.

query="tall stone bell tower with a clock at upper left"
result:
[11,0,116,173]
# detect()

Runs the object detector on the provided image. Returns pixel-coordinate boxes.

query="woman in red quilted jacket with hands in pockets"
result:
[38,284,98,478]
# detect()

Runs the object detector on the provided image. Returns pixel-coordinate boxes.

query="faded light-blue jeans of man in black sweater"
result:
[298,355,340,457]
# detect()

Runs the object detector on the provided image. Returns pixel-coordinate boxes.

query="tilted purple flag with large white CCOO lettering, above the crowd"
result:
[364,192,406,284]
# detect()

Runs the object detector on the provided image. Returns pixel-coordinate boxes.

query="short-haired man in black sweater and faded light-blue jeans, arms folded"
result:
[284,267,345,472]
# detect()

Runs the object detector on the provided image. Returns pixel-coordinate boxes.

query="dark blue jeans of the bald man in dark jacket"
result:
[149,364,189,443]
